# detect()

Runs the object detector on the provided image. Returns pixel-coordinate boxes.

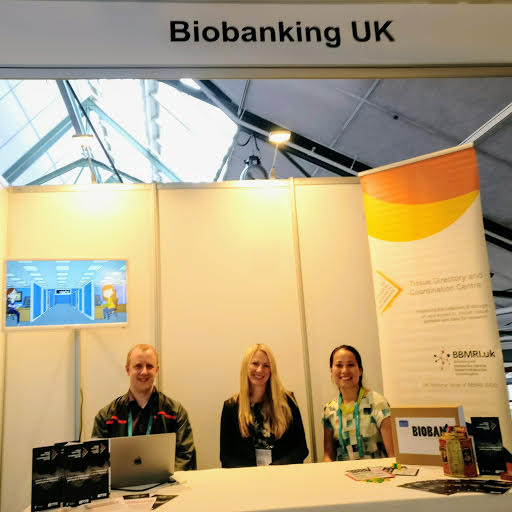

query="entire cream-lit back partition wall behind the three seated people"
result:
[0,179,381,512]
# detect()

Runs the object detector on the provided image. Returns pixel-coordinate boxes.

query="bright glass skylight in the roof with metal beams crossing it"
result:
[0,80,236,186]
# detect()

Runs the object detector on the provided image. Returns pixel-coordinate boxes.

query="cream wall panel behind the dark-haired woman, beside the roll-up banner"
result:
[296,178,382,460]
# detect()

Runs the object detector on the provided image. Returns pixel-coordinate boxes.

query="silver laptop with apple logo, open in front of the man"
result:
[110,434,176,489]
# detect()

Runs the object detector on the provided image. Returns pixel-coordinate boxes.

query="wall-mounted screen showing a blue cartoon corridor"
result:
[4,260,127,328]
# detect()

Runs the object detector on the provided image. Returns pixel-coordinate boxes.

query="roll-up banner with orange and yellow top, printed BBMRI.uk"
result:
[359,144,512,451]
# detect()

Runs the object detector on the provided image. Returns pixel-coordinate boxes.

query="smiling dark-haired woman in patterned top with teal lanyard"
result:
[322,345,394,462]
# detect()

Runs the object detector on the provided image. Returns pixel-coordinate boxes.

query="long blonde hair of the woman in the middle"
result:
[236,343,295,439]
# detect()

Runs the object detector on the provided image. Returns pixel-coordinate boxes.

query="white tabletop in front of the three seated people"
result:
[26,459,512,512]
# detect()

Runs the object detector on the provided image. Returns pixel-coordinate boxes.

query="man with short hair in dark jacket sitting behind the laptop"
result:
[92,344,197,471]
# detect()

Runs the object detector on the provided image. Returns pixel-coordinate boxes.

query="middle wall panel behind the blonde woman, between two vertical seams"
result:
[159,182,307,468]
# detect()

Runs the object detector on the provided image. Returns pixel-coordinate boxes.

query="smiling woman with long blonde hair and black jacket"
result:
[220,343,309,468]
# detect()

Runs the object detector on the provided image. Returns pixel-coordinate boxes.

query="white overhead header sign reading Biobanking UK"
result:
[0,0,512,69]
